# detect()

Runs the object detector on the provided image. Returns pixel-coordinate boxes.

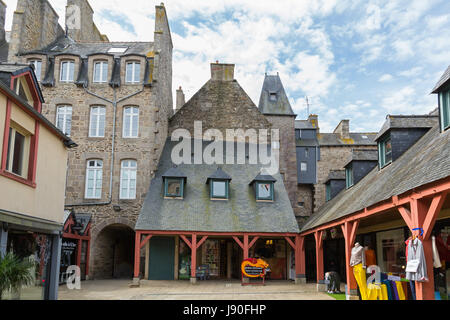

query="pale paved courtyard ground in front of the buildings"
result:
[59,280,334,300]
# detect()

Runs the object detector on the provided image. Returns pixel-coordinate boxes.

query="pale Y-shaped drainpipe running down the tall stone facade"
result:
[64,84,144,208]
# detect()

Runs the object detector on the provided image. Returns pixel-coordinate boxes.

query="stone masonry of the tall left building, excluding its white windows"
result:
[5,0,173,278]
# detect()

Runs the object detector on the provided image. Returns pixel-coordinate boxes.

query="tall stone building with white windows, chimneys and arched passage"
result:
[0,0,173,278]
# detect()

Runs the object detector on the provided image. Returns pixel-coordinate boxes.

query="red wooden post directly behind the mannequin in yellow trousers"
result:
[341,220,359,299]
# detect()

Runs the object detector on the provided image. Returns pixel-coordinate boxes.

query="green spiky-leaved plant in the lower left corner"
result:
[0,252,34,300]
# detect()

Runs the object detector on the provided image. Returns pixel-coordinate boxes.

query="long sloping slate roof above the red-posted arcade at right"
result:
[301,124,450,232]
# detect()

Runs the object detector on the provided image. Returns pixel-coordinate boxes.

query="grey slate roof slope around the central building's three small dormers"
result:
[135,139,299,233]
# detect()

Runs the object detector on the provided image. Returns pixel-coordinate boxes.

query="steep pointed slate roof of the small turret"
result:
[258,74,295,116]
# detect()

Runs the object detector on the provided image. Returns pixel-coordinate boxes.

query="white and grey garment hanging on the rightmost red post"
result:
[406,238,428,282]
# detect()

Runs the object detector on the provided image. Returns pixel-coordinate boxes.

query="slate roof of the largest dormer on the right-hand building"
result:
[375,114,439,141]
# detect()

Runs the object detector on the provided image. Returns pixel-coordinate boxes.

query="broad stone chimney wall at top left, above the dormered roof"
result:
[8,0,64,62]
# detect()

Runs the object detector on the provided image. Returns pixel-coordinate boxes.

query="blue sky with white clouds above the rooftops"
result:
[4,0,450,132]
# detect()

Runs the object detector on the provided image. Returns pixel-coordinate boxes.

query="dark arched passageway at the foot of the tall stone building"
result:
[93,224,135,279]
